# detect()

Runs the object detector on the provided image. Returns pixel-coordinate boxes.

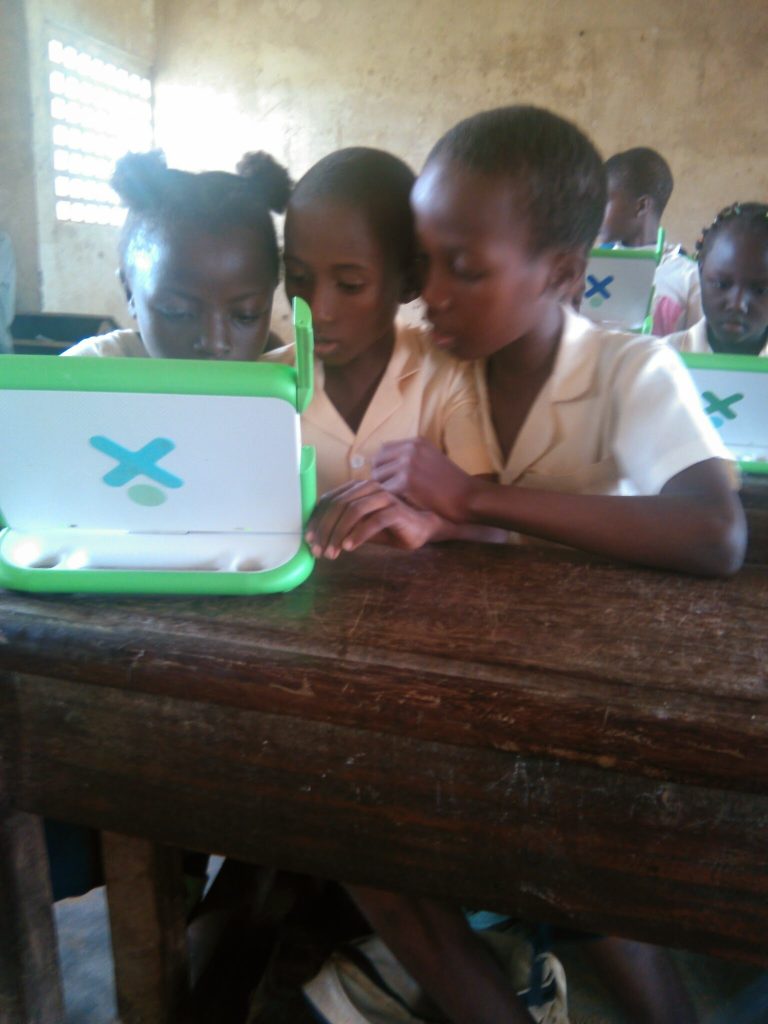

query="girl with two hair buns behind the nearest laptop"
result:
[62,152,291,359]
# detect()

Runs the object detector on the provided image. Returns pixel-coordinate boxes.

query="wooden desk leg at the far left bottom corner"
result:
[0,795,65,1024]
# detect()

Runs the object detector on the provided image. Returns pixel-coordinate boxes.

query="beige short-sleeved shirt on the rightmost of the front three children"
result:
[474,307,732,495]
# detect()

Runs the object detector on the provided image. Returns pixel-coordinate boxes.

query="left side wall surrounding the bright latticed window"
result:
[0,0,155,323]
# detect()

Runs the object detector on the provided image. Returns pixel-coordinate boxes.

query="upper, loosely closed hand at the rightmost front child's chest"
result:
[371,437,472,522]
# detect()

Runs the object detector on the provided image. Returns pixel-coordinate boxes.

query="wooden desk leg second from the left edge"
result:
[101,833,187,1024]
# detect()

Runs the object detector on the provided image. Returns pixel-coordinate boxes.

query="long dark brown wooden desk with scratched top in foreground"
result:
[0,546,768,1024]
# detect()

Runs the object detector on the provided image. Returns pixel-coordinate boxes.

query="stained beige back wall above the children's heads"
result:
[157,0,768,245]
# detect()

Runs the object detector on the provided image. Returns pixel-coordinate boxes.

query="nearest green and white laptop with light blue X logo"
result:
[0,299,315,594]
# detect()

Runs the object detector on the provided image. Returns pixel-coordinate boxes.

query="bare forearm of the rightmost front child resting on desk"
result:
[463,467,745,575]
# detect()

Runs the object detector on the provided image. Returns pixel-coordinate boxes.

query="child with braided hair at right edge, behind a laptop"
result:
[667,203,768,355]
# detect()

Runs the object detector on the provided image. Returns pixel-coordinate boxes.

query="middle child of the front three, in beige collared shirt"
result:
[285,147,490,494]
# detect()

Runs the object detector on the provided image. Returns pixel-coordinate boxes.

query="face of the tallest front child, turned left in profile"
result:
[412,159,559,359]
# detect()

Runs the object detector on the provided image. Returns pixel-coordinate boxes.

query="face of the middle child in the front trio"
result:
[285,199,402,366]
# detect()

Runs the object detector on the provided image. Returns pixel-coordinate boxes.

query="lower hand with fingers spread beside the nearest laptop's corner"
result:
[306,480,439,558]
